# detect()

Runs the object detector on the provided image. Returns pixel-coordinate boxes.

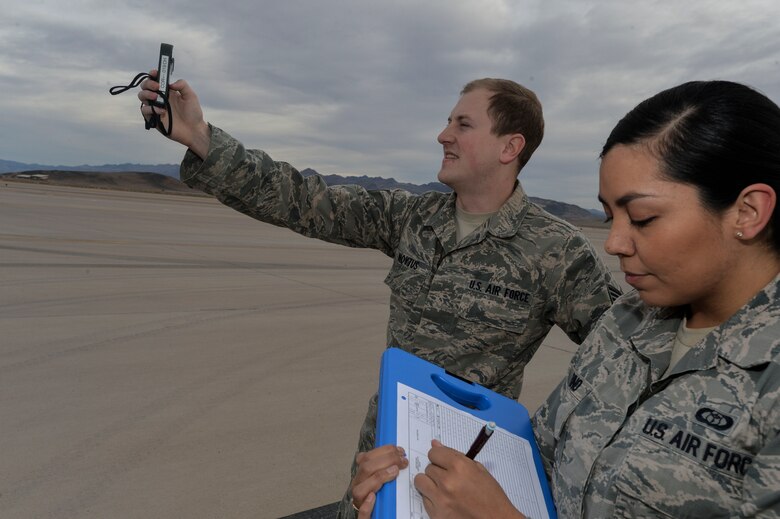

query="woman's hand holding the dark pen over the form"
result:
[414,440,525,519]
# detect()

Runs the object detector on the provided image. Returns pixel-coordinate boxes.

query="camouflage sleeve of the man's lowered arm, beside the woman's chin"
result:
[546,232,621,344]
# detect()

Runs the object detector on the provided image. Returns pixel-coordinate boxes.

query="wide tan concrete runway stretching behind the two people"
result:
[0,182,622,519]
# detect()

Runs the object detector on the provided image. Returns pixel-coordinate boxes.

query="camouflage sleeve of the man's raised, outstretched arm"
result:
[180,126,416,255]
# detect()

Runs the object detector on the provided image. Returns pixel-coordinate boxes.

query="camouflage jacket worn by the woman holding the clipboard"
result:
[534,276,780,518]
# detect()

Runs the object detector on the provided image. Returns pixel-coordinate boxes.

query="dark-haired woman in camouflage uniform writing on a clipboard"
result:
[353,81,780,518]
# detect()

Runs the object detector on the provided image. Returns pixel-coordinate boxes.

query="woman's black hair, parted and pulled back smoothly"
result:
[600,81,780,253]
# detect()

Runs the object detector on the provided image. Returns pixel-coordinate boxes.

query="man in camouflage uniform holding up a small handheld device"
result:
[139,79,619,517]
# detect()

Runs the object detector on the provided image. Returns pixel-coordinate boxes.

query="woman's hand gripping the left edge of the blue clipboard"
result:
[351,445,409,519]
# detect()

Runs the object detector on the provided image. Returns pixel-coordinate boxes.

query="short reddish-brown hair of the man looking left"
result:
[460,78,544,172]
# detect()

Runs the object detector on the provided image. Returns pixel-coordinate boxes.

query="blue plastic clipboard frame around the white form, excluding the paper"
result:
[372,348,557,519]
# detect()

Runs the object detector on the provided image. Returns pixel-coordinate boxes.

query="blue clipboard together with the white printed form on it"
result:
[373,348,556,519]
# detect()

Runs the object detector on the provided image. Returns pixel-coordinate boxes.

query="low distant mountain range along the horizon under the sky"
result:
[0,159,604,226]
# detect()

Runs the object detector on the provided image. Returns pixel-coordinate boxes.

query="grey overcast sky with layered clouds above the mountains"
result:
[0,0,780,208]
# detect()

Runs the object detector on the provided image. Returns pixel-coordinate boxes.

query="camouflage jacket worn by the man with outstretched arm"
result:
[181,127,619,398]
